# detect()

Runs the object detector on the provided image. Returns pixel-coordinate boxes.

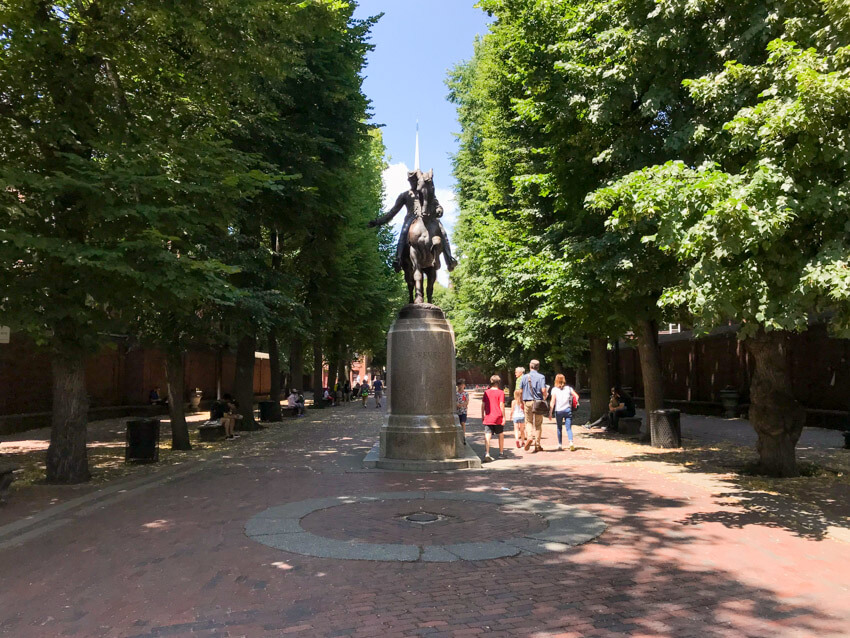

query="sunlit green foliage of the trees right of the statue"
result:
[450,0,850,370]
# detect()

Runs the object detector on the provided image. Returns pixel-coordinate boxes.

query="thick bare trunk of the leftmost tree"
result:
[47,355,91,484]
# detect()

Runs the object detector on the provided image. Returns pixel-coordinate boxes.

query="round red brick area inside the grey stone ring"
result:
[301,499,547,545]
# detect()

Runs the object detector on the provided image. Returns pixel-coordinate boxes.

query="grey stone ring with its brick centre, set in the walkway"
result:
[245,492,606,562]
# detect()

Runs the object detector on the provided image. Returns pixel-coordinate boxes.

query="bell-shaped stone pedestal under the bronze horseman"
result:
[364,304,481,471]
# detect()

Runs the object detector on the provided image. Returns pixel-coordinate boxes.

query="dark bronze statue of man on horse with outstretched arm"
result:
[369,169,457,303]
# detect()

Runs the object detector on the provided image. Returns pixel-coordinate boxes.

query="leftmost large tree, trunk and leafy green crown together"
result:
[0,0,266,483]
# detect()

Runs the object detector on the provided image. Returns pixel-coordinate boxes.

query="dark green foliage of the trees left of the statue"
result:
[0,0,394,358]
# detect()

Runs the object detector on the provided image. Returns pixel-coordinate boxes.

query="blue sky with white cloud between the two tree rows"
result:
[356,0,487,284]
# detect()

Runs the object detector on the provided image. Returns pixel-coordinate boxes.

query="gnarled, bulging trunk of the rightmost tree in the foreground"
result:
[745,330,806,477]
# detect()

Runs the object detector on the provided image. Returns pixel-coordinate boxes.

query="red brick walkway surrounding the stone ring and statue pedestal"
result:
[0,400,850,638]
